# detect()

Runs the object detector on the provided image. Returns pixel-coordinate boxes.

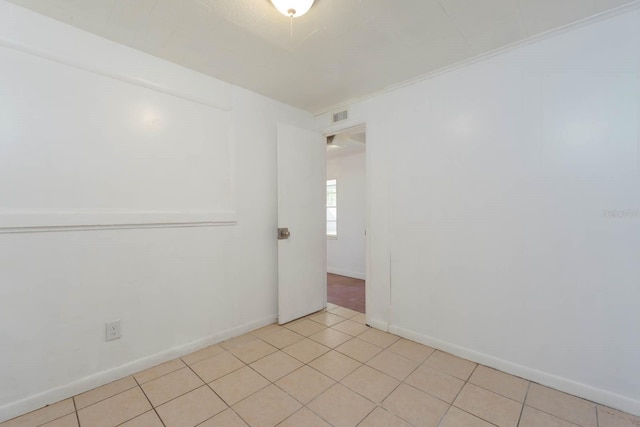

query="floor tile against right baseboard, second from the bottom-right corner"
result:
[525,383,597,427]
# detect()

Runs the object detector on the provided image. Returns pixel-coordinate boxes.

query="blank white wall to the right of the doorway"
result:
[317,8,640,414]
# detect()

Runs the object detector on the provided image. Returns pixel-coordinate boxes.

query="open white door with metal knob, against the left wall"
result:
[278,125,327,324]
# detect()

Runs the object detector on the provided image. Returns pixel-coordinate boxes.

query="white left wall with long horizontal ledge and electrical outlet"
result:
[0,1,313,421]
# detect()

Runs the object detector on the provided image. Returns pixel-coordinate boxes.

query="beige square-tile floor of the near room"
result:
[0,304,640,427]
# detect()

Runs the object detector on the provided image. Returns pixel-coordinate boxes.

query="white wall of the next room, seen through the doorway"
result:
[327,152,366,280]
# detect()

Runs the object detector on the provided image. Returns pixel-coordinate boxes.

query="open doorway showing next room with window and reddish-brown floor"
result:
[326,125,367,313]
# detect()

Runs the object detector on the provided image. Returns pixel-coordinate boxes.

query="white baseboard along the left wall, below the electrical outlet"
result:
[0,314,277,422]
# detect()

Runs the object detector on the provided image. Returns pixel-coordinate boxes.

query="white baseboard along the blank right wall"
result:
[388,325,640,415]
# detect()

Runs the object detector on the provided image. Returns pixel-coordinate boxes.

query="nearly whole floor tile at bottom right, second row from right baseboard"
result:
[453,383,522,427]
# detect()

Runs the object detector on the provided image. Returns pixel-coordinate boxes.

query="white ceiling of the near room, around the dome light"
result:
[9,0,635,112]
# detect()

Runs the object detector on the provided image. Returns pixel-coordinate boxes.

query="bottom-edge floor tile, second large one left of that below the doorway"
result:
[156,386,227,427]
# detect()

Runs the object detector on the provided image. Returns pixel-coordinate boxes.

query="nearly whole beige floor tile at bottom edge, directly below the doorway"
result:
[307,384,376,427]
